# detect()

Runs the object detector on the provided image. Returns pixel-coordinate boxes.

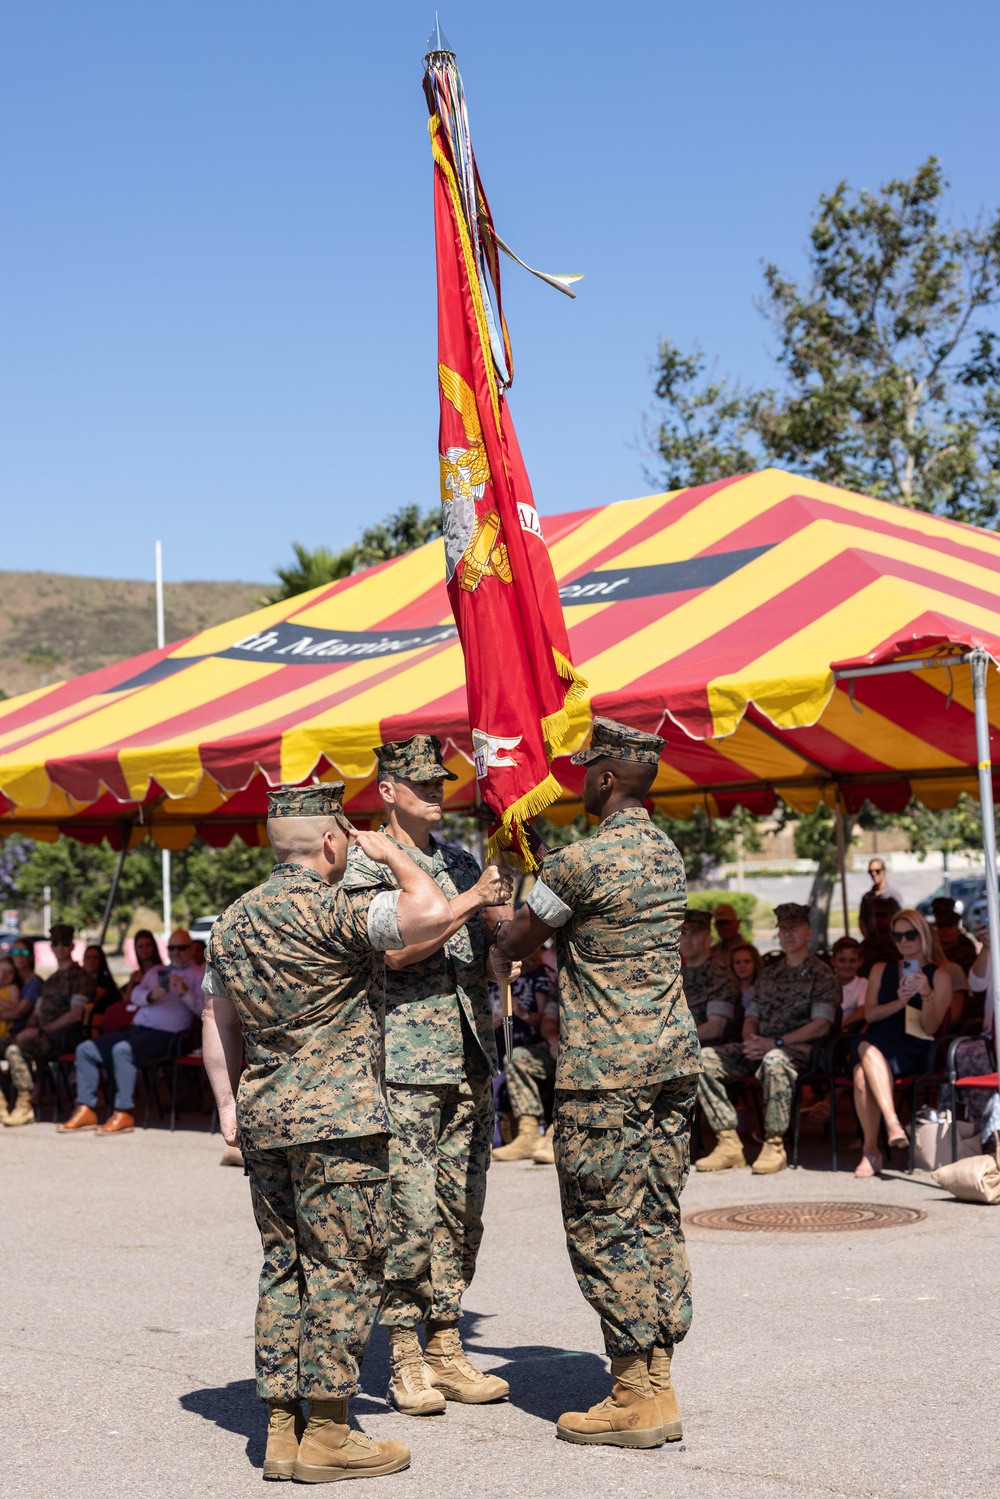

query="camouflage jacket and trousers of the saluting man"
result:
[204,833,402,1402]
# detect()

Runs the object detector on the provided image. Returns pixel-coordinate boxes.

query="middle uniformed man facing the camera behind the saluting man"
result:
[348,735,511,1415]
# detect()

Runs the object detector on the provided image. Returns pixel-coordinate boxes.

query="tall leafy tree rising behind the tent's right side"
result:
[655,157,1000,525]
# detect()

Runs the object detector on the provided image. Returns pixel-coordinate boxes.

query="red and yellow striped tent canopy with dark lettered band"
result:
[0,469,1000,848]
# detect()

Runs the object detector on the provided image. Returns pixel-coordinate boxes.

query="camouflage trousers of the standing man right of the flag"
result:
[553,1076,697,1358]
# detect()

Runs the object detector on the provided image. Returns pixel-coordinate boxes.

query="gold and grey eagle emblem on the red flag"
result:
[438,364,513,594]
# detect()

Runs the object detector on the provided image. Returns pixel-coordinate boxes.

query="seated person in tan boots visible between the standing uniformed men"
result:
[490,947,559,1166]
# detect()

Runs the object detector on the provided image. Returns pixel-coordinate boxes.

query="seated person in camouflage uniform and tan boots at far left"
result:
[0,922,97,1127]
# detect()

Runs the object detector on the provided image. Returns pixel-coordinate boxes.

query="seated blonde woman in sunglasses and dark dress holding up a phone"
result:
[852,910,952,1177]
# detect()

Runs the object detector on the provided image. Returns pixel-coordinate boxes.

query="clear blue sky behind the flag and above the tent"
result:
[0,0,1000,580]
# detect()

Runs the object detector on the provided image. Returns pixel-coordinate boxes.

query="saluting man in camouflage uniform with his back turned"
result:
[204,781,451,1483]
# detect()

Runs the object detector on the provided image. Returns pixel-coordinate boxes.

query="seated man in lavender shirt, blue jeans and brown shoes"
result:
[58,928,205,1135]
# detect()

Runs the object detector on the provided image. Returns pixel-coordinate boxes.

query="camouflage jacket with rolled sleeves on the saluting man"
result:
[207,863,399,1151]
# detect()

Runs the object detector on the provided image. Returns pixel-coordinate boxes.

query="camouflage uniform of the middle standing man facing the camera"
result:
[345,835,496,1328]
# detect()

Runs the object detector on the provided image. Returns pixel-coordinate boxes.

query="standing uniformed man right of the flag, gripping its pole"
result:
[498,718,699,1447]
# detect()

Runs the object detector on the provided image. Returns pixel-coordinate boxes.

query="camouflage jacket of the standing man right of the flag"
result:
[528,808,700,1088]
